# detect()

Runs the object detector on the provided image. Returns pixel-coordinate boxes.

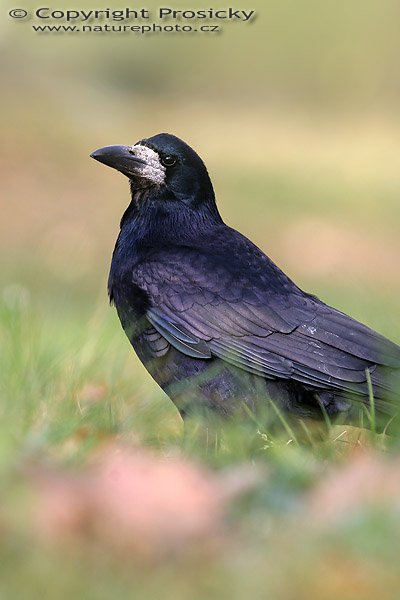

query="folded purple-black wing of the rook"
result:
[134,242,400,394]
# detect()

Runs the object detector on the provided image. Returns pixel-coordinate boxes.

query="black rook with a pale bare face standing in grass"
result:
[91,133,400,428]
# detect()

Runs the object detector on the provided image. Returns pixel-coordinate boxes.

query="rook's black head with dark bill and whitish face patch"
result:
[91,133,214,207]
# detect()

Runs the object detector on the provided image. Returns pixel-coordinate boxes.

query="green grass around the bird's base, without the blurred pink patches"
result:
[0,287,400,600]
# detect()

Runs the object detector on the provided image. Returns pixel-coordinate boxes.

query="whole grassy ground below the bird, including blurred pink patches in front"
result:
[0,285,400,600]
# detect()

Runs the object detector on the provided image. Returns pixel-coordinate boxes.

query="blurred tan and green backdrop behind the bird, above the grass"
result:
[0,0,400,328]
